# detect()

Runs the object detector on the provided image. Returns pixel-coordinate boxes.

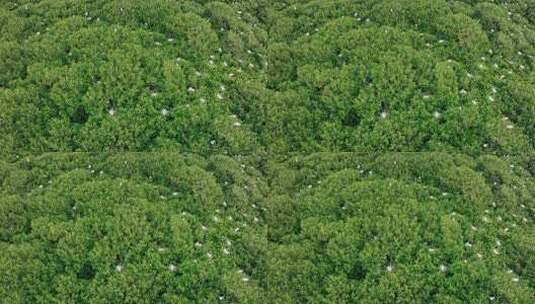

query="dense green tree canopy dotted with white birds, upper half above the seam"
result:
[0,0,535,153]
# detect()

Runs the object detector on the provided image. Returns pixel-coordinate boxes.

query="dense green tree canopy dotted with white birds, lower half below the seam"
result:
[0,153,535,303]
